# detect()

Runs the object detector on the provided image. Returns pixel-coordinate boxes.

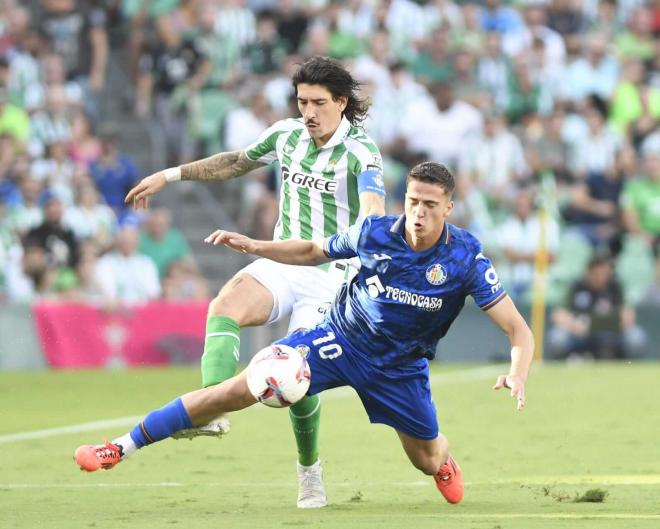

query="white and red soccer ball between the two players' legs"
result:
[247,344,311,408]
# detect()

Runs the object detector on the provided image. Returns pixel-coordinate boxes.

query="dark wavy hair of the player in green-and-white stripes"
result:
[291,56,369,125]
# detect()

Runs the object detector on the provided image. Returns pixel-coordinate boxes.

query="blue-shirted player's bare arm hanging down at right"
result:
[486,296,534,411]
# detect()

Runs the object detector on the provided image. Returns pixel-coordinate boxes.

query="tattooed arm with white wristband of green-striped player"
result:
[124,151,264,209]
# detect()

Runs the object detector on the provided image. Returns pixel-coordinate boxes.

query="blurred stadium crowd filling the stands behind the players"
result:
[0,0,660,356]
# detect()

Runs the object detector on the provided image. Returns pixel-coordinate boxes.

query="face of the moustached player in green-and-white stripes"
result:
[298,83,347,147]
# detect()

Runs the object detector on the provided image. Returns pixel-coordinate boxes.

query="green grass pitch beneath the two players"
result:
[0,363,660,529]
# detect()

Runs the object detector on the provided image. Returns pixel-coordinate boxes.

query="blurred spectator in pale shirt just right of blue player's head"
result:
[459,112,528,207]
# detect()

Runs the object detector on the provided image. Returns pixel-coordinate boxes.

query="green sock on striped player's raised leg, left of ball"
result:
[202,316,241,387]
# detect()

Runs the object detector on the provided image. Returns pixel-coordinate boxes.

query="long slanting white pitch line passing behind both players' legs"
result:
[0,365,506,444]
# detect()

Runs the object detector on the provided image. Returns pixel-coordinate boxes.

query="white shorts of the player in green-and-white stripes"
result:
[241,259,351,332]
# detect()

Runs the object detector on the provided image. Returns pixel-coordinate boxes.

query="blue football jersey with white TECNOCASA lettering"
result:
[325,215,506,366]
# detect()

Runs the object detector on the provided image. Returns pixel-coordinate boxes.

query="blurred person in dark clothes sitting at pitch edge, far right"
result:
[548,256,645,359]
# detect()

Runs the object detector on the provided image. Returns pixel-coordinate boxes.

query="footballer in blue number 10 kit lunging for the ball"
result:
[76,162,534,503]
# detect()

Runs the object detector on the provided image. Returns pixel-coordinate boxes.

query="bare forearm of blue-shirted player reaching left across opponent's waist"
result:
[204,230,332,265]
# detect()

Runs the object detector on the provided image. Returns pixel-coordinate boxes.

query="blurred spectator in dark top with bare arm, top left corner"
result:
[38,0,109,119]
